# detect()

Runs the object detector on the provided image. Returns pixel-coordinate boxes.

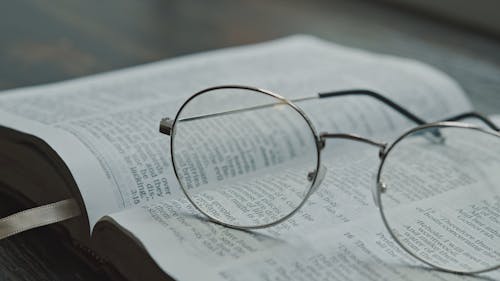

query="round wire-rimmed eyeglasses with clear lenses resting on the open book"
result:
[160,86,500,273]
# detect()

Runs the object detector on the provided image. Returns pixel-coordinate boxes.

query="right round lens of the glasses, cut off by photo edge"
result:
[379,125,500,273]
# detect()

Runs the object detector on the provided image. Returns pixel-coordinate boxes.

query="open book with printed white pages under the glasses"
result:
[0,36,500,280]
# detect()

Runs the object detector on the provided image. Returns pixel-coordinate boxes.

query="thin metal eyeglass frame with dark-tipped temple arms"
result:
[159,85,500,274]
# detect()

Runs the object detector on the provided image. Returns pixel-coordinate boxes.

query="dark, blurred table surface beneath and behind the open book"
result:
[0,0,500,281]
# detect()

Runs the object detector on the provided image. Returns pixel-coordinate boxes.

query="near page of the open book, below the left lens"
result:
[106,161,500,280]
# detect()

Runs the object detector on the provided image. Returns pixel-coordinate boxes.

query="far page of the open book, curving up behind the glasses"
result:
[0,36,471,226]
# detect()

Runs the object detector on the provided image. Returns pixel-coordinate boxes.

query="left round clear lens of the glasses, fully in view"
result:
[171,87,319,228]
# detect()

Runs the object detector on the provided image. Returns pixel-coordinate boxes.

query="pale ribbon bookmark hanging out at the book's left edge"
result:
[0,199,81,240]
